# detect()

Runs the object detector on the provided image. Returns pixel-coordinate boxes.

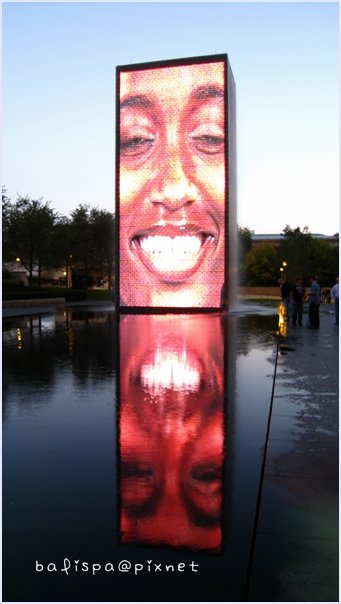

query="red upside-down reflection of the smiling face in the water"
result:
[120,317,223,551]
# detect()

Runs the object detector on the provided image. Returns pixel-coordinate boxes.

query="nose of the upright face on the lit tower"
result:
[150,153,199,212]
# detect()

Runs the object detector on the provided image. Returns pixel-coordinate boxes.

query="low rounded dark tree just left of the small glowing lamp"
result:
[245,243,278,286]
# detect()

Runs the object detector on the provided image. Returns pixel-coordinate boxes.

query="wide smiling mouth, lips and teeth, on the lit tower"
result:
[130,225,216,283]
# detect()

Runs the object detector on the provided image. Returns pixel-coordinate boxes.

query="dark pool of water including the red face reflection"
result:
[3,309,278,601]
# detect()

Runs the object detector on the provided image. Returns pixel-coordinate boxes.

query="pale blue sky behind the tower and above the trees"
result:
[2,2,339,235]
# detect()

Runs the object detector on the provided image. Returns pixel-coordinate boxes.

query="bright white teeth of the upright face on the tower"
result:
[140,235,202,271]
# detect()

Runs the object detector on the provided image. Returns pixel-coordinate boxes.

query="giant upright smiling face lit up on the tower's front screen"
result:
[119,61,226,308]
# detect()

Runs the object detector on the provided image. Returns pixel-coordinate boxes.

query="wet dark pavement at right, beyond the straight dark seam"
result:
[248,305,339,602]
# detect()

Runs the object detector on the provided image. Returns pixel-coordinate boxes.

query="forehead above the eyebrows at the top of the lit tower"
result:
[120,62,224,98]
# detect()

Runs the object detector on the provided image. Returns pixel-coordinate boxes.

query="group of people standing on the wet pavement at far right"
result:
[279,275,339,329]
